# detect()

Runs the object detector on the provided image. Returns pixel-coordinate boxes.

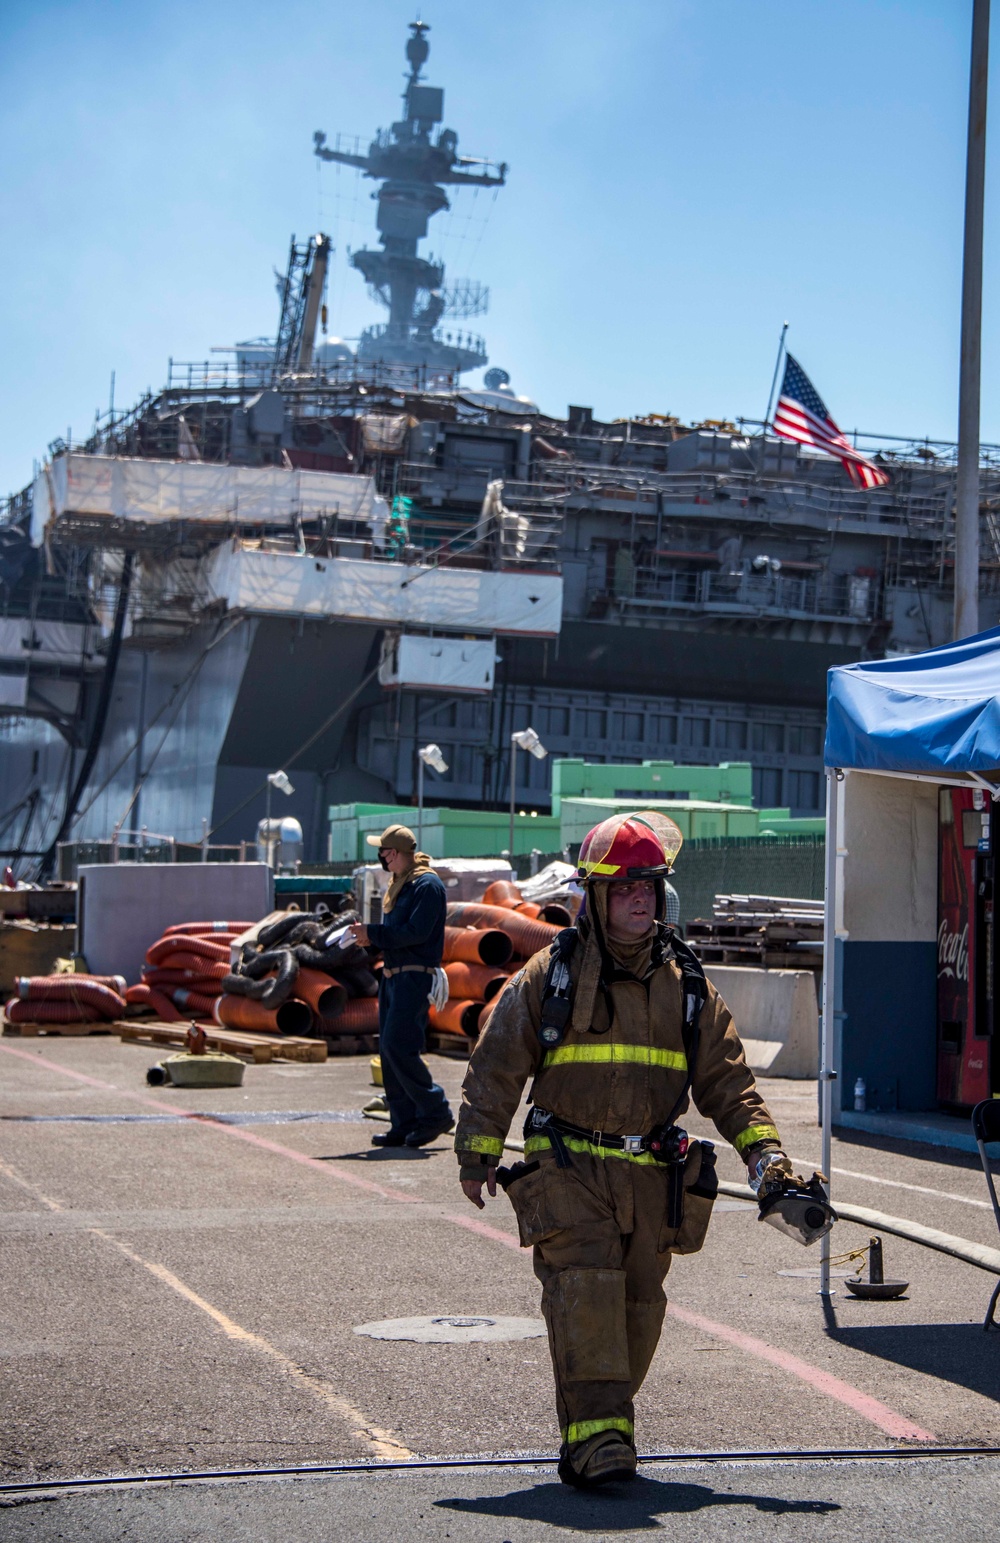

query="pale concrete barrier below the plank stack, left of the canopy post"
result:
[705,964,819,1077]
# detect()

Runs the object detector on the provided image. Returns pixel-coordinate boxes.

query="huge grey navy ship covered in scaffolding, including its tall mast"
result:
[0,29,1000,864]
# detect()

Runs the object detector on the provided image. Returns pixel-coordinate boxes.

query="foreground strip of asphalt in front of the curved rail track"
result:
[0,1458,1000,1543]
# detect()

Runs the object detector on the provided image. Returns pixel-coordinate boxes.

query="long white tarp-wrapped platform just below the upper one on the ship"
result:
[207,542,562,637]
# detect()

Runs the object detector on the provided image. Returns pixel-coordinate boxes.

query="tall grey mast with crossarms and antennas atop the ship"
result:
[313,22,508,375]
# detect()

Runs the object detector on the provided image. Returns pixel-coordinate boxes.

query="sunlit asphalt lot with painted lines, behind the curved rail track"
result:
[0,1035,1000,1512]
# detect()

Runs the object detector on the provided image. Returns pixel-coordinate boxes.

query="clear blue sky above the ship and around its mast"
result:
[0,0,1000,491]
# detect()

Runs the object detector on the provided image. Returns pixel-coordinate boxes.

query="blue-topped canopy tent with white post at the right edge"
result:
[819,628,1000,1295]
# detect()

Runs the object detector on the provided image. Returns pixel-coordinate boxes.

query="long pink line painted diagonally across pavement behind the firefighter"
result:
[0,1045,937,1441]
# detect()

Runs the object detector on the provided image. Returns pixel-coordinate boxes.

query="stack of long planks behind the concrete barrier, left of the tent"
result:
[685,895,823,969]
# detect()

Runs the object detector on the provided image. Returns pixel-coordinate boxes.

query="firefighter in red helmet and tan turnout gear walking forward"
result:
[455,810,784,1487]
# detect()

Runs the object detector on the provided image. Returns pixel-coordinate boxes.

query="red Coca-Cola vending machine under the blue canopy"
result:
[937,787,1000,1111]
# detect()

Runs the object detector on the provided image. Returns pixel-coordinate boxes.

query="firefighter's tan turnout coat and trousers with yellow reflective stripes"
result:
[455,946,778,1446]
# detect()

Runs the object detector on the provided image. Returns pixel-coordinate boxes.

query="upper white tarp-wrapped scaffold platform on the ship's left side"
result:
[31,452,386,546]
